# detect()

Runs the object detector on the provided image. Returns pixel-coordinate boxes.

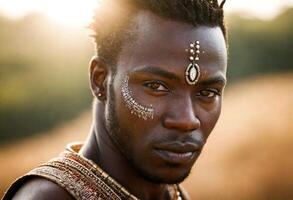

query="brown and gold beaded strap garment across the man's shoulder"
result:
[3,144,188,200]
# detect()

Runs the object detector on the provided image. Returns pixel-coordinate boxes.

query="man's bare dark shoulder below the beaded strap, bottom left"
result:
[12,178,73,200]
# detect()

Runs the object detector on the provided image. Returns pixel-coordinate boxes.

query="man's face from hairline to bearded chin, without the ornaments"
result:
[106,12,227,183]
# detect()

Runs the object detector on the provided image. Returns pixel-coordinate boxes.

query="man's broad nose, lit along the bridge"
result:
[163,98,200,132]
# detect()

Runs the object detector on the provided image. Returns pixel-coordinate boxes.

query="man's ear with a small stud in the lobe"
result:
[89,56,109,101]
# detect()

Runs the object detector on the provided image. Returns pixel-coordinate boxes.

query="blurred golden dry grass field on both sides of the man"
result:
[0,74,293,200]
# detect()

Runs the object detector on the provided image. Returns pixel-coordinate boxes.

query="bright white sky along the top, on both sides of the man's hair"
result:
[0,0,293,26]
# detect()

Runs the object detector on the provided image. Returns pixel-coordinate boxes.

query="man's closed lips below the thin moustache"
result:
[155,142,202,165]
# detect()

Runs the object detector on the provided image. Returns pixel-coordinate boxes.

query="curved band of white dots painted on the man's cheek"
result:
[121,76,154,120]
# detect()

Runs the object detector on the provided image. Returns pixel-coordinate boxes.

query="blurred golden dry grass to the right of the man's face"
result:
[185,74,293,200]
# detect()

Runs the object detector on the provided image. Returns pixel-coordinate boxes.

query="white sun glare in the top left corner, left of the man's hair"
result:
[0,0,98,26]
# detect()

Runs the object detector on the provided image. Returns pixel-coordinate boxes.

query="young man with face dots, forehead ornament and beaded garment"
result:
[4,0,227,200]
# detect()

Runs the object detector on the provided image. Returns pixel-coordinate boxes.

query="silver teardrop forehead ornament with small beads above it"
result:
[185,41,200,85]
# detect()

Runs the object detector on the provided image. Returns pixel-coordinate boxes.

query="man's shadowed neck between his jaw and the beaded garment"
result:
[80,120,174,200]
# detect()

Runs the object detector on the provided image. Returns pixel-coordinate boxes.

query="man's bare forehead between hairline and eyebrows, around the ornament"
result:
[117,11,227,78]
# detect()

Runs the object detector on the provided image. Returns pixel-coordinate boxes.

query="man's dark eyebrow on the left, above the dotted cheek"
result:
[133,66,180,81]
